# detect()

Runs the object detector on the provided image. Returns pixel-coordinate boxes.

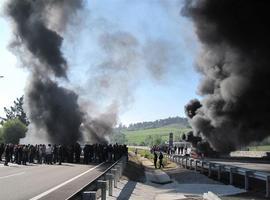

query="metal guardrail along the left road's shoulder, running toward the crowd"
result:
[66,156,127,200]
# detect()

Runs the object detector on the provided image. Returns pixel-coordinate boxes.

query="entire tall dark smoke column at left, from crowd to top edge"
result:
[6,0,82,144]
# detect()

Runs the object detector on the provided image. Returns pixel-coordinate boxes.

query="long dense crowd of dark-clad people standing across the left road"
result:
[0,143,128,166]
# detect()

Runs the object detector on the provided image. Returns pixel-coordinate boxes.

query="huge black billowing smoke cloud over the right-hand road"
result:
[183,0,270,152]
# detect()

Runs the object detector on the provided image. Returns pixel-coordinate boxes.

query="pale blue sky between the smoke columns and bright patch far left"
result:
[0,0,200,125]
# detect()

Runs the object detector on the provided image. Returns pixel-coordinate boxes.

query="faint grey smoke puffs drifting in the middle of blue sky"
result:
[85,30,179,112]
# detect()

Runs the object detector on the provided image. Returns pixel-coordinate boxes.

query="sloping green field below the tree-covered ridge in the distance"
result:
[123,124,191,145]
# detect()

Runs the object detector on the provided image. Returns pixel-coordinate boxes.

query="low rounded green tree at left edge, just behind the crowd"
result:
[1,119,27,144]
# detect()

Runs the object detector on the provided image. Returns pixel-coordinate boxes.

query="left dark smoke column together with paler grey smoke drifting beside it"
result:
[6,0,179,144]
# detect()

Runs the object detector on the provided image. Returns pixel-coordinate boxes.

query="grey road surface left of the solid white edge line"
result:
[0,163,105,200]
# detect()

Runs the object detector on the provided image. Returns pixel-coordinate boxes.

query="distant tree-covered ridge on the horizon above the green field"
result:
[116,117,189,131]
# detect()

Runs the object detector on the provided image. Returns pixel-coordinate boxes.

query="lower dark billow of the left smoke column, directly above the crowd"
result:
[27,79,82,144]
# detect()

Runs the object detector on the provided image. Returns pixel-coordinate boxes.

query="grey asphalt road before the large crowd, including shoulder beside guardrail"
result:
[0,163,108,200]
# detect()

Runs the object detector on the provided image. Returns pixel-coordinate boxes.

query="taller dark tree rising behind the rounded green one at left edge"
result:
[1,96,29,126]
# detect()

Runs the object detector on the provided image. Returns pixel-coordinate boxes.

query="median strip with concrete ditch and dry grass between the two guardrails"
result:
[108,152,243,200]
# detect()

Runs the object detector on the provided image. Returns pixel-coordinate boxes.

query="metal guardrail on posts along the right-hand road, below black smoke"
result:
[165,154,270,197]
